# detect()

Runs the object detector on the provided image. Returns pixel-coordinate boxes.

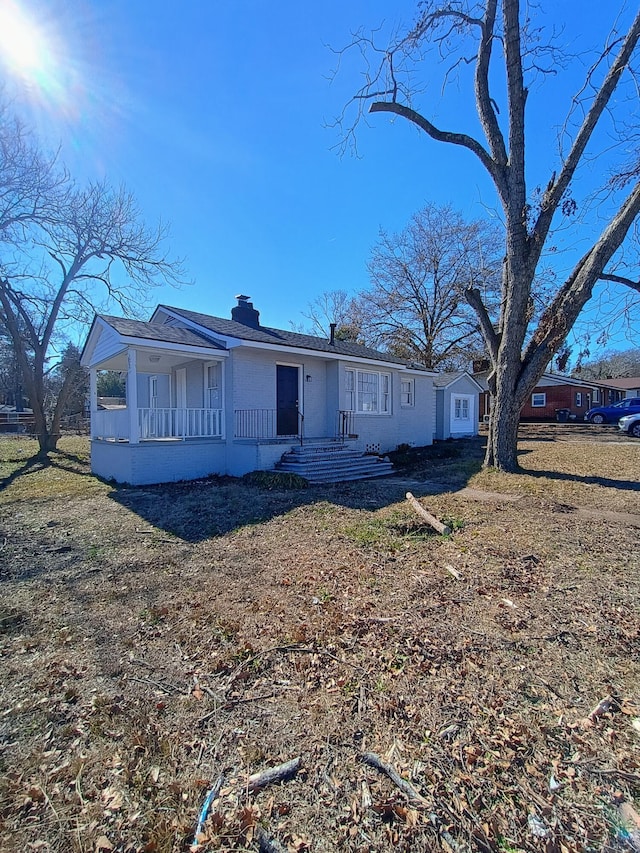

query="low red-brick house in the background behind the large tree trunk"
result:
[473,370,622,422]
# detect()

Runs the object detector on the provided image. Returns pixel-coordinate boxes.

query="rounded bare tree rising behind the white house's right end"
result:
[360,205,501,370]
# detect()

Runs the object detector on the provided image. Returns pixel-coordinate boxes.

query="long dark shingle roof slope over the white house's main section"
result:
[158,305,420,365]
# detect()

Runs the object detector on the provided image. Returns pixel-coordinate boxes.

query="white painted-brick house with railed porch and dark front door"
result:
[82,296,435,485]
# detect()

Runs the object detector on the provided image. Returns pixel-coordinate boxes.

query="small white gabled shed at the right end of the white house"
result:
[433,371,482,441]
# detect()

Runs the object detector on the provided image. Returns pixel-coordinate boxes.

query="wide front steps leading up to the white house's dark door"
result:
[275,442,393,484]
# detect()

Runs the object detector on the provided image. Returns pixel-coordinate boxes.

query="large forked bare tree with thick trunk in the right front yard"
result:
[336,0,640,471]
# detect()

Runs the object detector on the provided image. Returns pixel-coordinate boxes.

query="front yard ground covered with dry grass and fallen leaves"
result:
[0,424,640,853]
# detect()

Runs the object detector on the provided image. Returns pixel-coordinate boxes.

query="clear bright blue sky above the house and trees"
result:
[0,0,633,348]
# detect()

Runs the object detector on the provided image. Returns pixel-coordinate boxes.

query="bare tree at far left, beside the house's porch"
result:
[0,111,182,455]
